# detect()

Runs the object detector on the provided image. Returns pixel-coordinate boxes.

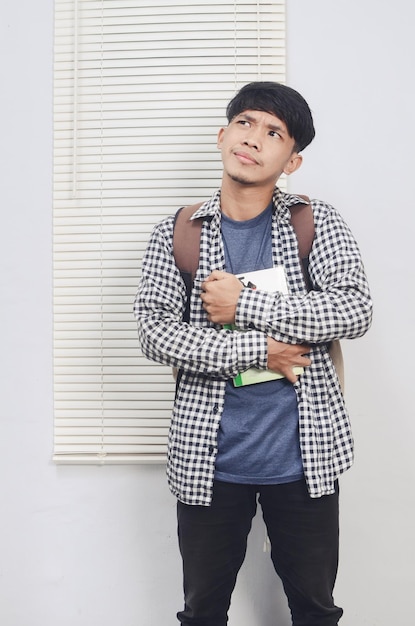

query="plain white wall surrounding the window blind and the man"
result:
[0,0,415,626]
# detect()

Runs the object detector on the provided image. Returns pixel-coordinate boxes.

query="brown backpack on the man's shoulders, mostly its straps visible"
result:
[173,195,344,392]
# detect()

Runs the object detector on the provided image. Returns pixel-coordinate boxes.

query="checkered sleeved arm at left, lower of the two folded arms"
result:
[134,218,267,378]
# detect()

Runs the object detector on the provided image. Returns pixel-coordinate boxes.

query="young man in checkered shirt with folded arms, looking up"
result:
[135,82,372,626]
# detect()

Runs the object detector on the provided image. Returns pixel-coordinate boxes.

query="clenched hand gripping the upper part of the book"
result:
[200,270,244,324]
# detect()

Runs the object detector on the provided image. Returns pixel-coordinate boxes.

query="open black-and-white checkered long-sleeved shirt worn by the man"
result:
[134,188,372,505]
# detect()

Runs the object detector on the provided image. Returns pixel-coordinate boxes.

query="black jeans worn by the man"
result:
[177,480,343,626]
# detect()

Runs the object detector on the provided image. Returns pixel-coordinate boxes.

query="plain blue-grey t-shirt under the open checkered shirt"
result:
[215,205,303,484]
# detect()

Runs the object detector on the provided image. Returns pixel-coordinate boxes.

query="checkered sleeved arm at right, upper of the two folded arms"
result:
[235,204,372,343]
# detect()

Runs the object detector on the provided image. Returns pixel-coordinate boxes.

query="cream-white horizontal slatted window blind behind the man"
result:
[53,0,285,463]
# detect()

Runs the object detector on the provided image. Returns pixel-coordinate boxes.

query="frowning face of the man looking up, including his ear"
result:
[218,110,302,185]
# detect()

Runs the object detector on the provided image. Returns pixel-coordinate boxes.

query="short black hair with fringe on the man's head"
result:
[226,81,315,152]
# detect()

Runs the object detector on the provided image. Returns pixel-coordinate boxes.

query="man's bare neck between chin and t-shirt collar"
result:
[220,177,274,221]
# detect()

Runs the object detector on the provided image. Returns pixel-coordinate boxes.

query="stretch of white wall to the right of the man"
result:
[287,0,415,626]
